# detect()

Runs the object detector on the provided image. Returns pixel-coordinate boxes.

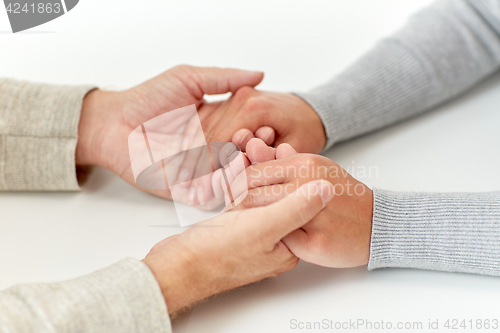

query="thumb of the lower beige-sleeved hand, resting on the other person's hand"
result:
[247,179,334,244]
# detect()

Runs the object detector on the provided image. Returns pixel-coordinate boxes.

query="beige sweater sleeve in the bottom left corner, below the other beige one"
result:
[0,259,172,333]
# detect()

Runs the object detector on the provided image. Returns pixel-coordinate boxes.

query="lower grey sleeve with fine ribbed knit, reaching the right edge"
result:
[368,189,500,276]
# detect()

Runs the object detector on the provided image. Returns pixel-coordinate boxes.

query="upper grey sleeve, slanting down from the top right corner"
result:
[297,0,500,149]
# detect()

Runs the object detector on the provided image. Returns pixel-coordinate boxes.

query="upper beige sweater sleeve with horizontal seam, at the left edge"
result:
[0,79,94,191]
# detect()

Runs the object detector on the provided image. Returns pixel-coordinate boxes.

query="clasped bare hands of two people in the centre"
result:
[76,66,373,314]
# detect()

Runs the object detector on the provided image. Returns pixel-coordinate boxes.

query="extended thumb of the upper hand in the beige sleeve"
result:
[175,65,264,99]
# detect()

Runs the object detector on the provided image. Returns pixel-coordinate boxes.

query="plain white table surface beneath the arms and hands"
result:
[0,0,500,333]
